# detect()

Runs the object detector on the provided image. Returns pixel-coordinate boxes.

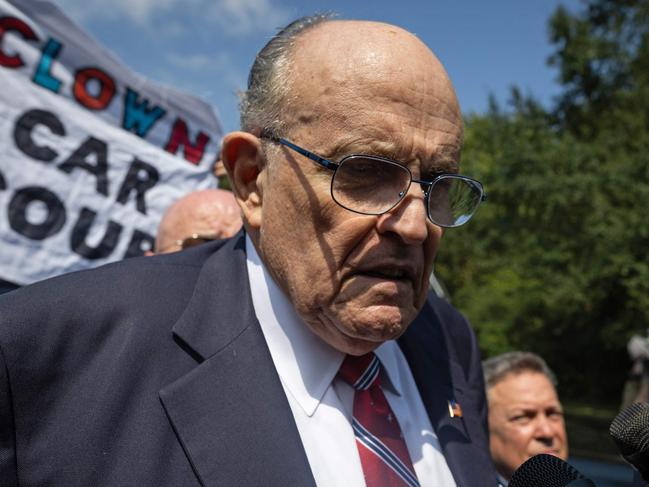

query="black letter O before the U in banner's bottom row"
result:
[9,186,65,240]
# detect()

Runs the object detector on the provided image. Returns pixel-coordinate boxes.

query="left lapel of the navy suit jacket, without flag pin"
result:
[160,237,315,487]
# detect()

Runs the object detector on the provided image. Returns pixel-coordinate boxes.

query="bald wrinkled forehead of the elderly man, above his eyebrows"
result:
[278,21,462,150]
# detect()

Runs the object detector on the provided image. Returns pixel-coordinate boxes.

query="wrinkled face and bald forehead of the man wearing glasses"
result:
[248,22,462,354]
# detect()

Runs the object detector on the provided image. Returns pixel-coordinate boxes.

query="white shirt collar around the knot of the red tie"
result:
[246,234,401,416]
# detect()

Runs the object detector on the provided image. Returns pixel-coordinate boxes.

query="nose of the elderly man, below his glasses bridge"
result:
[377,184,429,245]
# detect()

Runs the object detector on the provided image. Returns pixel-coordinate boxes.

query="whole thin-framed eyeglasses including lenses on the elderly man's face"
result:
[262,134,487,228]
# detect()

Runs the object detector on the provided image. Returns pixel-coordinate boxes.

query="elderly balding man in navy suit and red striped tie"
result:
[0,16,496,487]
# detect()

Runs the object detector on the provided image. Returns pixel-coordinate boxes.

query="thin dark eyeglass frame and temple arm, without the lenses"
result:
[260,133,487,228]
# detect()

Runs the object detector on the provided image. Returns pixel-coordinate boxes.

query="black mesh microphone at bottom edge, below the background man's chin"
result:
[509,453,596,487]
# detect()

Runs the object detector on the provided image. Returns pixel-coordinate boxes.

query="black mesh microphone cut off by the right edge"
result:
[609,402,649,482]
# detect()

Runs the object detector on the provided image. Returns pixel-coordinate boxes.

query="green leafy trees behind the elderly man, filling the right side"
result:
[436,0,649,401]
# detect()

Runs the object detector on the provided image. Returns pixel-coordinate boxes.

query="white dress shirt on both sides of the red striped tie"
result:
[246,235,455,487]
